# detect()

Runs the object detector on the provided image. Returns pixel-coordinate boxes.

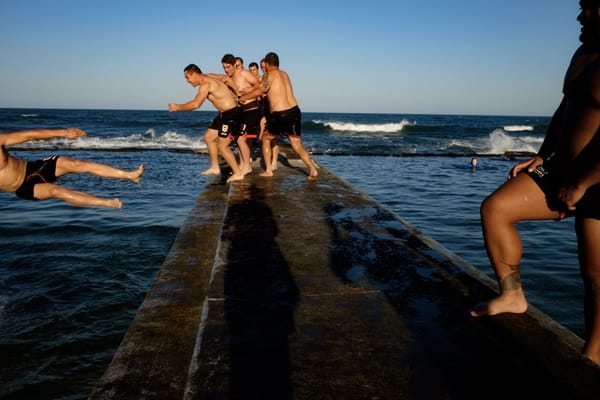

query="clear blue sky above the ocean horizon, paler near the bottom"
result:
[0,0,580,116]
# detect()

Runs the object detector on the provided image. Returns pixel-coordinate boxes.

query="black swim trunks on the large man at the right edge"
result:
[524,158,600,219]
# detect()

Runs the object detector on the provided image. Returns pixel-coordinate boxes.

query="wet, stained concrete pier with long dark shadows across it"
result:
[89,153,600,400]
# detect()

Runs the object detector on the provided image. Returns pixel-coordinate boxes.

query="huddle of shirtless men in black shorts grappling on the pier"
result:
[169,52,319,182]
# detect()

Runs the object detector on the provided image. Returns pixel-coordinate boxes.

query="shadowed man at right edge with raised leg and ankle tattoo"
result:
[471,0,600,364]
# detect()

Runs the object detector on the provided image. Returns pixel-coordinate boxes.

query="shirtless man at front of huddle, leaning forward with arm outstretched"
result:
[169,64,244,182]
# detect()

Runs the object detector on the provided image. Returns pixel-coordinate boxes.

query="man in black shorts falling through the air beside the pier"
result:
[0,128,144,208]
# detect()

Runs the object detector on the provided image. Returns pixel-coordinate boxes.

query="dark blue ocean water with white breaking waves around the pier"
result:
[0,109,583,399]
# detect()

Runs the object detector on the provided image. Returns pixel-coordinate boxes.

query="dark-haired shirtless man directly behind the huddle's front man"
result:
[221,54,263,175]
